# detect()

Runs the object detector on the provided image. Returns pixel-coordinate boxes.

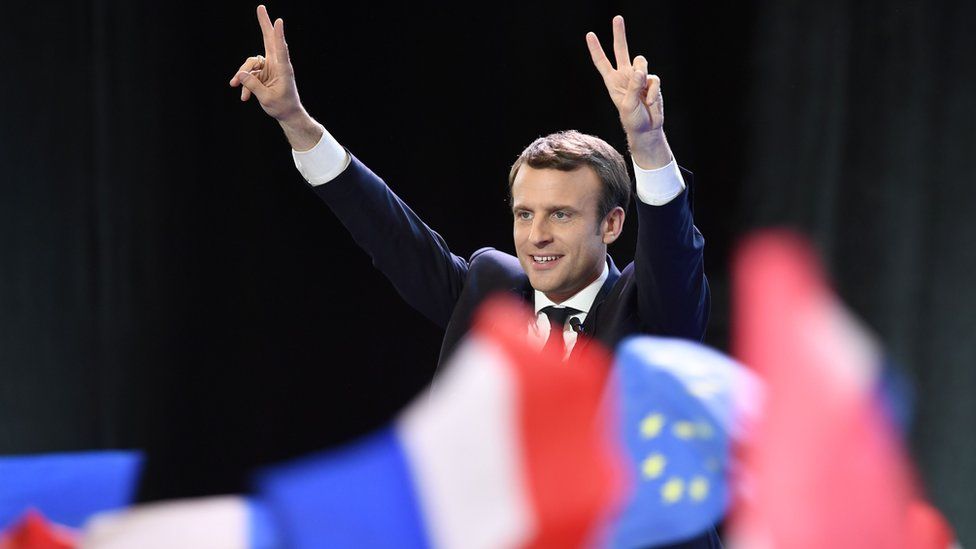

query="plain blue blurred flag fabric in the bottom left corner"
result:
[0,451,142,532]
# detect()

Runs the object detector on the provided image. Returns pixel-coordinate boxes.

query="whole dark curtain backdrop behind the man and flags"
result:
[0,0,976,543]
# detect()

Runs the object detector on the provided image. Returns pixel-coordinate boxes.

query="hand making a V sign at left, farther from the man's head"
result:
[230,6,304,122]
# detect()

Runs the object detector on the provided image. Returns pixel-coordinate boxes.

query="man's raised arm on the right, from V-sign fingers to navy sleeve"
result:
[586,15,709,339]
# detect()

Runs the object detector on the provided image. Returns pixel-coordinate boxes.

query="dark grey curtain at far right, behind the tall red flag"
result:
[737,1,976,545]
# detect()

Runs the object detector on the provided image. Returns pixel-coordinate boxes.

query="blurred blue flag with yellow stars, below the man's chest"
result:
[611,336,761,548]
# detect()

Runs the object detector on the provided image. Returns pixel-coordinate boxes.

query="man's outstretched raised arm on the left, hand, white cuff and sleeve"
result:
[230,6,468,327]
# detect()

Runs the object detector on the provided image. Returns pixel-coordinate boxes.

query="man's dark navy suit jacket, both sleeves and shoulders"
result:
[314,152,720,547]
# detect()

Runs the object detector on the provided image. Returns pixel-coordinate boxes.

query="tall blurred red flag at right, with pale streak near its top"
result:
[732,232,952,549]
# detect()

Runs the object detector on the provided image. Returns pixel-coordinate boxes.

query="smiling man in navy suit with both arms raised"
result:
[230,6,709,370]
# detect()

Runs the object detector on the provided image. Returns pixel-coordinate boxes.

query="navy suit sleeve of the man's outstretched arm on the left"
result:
[313,154,468,328]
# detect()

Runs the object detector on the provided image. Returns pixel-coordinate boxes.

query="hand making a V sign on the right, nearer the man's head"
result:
[586,15,671,168]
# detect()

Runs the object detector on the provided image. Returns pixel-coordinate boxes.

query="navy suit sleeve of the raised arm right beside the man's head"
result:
[634,169,710,340]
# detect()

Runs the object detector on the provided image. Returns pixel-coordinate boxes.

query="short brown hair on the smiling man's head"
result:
[508,130,630,222]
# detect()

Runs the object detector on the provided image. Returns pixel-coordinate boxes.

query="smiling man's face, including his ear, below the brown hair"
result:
[512,165,623,303]
